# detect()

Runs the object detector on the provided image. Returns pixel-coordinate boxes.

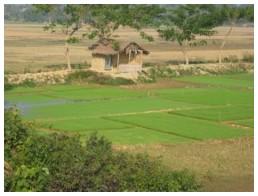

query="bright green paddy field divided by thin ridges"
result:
[5,74,254,144]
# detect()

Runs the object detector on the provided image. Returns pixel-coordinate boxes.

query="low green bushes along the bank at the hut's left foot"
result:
[66,71,134,85]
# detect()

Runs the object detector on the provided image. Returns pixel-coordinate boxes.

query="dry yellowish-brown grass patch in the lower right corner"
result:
[114,138,254,191]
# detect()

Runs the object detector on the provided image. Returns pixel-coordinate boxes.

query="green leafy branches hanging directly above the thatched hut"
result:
[83,5,164,46]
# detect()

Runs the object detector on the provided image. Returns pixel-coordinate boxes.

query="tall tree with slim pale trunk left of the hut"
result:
[35,4,87,70]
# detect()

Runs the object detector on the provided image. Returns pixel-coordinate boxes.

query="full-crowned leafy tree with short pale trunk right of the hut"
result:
[158,5,219,64]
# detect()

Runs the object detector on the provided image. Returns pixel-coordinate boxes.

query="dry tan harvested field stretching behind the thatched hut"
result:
[4,24,254,72]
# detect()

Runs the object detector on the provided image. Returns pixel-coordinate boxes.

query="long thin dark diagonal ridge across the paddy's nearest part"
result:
[102,117,203,141]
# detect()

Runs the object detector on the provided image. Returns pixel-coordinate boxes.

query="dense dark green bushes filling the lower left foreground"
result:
[4,108,200,191]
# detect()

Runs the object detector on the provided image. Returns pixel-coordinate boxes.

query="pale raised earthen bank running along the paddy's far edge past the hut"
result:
[5,63,254,84]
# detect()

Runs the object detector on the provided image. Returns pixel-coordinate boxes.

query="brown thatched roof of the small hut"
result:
[89,39,150,55]
